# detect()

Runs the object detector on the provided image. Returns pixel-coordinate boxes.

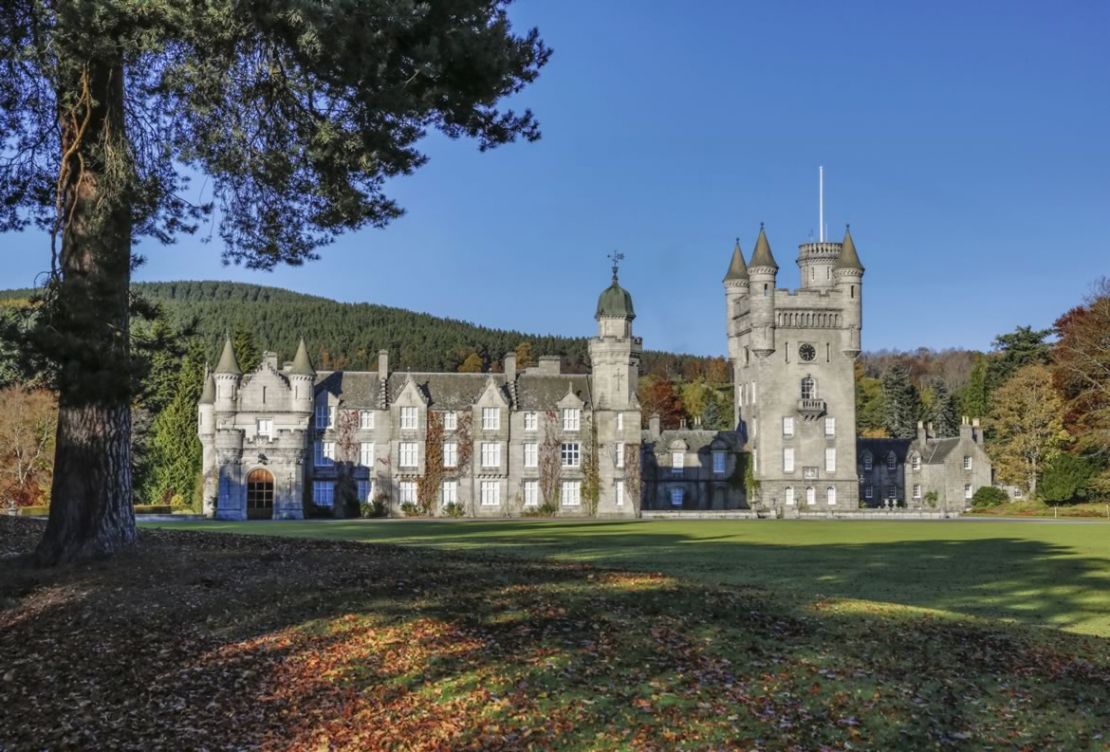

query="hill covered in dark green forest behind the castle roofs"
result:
[0,281,707,374]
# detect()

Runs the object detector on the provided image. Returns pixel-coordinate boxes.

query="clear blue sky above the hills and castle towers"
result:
[0,0,1110,354]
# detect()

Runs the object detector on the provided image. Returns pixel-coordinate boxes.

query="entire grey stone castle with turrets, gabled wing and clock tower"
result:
[198,227,990,519]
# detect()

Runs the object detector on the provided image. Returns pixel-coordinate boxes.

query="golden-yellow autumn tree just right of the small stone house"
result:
[987,363,1068,494]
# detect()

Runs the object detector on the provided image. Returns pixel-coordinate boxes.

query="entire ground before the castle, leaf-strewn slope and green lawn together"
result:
[0,518,1110,751]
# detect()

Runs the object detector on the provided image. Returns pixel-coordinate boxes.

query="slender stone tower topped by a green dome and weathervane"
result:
[589,254,643,517]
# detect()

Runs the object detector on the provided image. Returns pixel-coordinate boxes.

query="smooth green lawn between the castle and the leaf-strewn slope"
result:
[157,520,1110,636]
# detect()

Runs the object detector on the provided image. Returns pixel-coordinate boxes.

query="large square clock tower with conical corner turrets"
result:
[725,227,864,515]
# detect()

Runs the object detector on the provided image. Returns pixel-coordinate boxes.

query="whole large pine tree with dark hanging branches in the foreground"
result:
[0,0,549,563]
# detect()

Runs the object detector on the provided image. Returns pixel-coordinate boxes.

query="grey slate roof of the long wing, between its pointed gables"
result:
[316,371,592,410]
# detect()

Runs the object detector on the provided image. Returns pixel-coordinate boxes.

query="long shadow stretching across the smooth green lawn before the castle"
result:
[164,521,1110,635]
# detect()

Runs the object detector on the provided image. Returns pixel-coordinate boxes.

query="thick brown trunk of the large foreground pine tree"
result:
[36,60,135,564]
